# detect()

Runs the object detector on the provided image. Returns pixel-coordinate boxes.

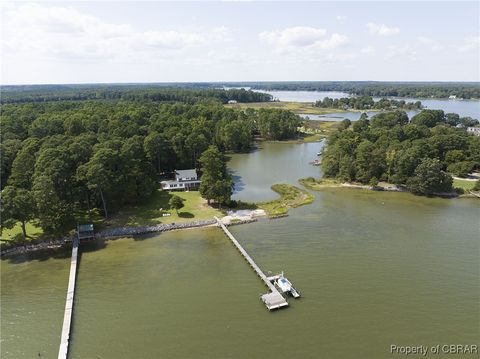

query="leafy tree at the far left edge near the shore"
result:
[1,186,35,239]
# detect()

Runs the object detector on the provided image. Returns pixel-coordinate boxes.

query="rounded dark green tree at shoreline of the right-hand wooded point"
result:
[407,158,453,194]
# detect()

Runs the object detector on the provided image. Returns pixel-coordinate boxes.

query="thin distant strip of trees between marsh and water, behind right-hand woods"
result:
[315,96,422,110]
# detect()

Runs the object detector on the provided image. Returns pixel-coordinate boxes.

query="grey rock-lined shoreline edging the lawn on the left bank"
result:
[0,218,257,257]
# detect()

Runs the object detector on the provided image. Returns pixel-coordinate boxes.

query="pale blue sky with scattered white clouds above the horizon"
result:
[0,1,480,84]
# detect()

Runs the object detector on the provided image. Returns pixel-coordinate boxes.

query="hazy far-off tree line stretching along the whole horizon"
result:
[1,81,480,103]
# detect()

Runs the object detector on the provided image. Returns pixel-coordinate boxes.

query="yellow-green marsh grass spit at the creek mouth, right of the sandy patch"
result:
[258,184,315,217]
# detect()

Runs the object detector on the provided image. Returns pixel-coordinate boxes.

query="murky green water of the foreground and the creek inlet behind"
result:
[1,143,480,358]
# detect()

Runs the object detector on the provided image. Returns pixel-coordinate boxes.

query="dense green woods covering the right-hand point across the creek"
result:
[322,110,480,194]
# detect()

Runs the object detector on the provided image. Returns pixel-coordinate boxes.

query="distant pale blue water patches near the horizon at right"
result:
[262,91,480,121]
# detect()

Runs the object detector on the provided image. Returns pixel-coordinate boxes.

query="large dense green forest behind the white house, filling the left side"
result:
[0,89,300,238]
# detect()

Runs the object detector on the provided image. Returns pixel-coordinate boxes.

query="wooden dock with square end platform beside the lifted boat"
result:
[214,217,288,310]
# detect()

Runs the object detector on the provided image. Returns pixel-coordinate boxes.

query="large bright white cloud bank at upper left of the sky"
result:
[2,3,229,61]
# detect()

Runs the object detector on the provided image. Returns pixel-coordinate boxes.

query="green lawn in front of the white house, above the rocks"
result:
[105,190,223,227]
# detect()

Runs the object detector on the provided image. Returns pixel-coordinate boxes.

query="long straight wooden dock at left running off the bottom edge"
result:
[58,237,79,359]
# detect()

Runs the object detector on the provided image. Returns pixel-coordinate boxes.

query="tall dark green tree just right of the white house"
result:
[199,146,233,204]
